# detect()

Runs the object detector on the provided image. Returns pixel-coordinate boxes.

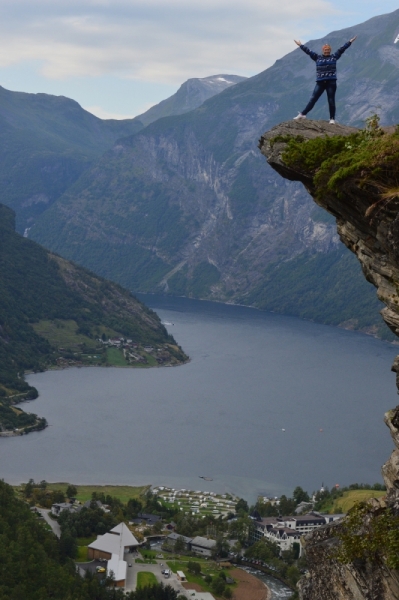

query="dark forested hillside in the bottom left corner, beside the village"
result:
[0,481,182,600]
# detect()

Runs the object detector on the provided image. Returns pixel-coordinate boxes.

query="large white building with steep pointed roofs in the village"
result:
[87,523,139,587]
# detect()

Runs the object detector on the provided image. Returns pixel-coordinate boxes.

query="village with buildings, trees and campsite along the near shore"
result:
[22,477,366,600]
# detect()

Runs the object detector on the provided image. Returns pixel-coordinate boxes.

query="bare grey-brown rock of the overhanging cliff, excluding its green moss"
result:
[259,120,399,600]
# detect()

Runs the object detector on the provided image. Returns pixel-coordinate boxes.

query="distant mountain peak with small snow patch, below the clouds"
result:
[136,75,246,125]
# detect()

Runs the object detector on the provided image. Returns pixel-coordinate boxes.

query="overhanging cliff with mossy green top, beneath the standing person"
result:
[259,121,399,600]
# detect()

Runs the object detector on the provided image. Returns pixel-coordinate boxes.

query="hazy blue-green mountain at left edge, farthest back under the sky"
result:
[0,87,142,232]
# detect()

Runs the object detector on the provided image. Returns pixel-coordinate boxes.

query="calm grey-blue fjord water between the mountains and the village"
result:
[0,295,397,501]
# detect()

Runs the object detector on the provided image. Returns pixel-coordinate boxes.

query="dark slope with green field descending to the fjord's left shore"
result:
[0,205,187,431]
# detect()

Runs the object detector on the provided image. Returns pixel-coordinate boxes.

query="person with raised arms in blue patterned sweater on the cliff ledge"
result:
[294,35,357,125]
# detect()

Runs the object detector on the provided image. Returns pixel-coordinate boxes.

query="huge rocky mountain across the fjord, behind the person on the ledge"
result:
[31,11,399,336]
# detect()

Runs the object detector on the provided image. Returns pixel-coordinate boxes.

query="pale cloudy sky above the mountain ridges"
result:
[0,0,398,119]
